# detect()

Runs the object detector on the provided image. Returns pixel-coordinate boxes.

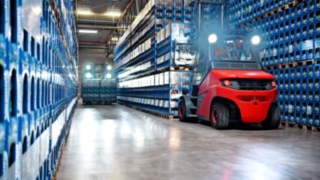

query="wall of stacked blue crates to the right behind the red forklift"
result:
[229,0,320,127]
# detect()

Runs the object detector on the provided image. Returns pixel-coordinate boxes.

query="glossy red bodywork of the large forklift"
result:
[197,70,277,123]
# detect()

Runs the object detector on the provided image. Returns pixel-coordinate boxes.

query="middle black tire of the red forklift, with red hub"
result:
[210,102,230,129]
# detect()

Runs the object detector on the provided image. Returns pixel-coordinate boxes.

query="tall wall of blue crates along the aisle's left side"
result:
[0,0,78,180]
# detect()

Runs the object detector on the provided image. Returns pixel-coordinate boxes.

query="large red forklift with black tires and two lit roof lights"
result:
[178,31,281,129]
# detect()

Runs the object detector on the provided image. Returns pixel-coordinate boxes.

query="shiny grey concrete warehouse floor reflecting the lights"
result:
[57,105,320,180]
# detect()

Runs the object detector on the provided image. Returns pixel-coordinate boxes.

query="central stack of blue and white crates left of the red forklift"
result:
[115,1,194,116]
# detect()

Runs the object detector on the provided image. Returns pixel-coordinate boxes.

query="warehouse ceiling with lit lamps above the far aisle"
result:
[76,0,147,56]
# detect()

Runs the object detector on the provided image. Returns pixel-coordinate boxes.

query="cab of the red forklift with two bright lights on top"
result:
[192,34,262,96]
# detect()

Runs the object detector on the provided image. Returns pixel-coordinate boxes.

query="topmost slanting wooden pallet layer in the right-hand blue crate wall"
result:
[241,0,305,26]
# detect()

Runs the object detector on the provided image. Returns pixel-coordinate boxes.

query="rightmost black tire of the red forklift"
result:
[262,104,281,129]
